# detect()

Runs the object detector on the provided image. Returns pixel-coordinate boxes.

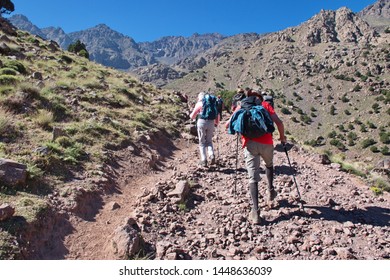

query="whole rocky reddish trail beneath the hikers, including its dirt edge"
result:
[44,127,390,260]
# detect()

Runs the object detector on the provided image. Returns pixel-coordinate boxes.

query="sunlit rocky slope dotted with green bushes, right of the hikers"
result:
[165,8,390,177]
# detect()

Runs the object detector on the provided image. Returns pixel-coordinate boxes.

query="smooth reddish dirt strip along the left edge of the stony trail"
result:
[64,137,195,260]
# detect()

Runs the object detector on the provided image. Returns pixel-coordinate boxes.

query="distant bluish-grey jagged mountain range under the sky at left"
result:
[9,15,225,70]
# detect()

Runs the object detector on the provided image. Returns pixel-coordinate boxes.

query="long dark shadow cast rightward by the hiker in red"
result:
[269,200,390,227]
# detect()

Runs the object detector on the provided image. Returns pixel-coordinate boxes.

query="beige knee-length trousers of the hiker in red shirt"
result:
[244,140,274,183]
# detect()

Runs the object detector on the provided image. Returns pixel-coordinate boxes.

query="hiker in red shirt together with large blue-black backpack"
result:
[226,89,286,224]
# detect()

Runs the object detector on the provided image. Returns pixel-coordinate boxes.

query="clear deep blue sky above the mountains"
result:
[11,0,376,42]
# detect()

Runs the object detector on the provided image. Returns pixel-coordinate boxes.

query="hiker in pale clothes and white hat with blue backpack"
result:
[190,92,219,167]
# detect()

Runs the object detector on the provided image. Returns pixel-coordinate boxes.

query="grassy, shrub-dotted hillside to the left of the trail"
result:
[0,22,186,259]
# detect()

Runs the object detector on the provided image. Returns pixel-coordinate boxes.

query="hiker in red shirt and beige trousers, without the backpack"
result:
[225,89,286,224]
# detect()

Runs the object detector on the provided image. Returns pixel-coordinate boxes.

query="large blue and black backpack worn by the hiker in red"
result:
[229,96,275,138]
